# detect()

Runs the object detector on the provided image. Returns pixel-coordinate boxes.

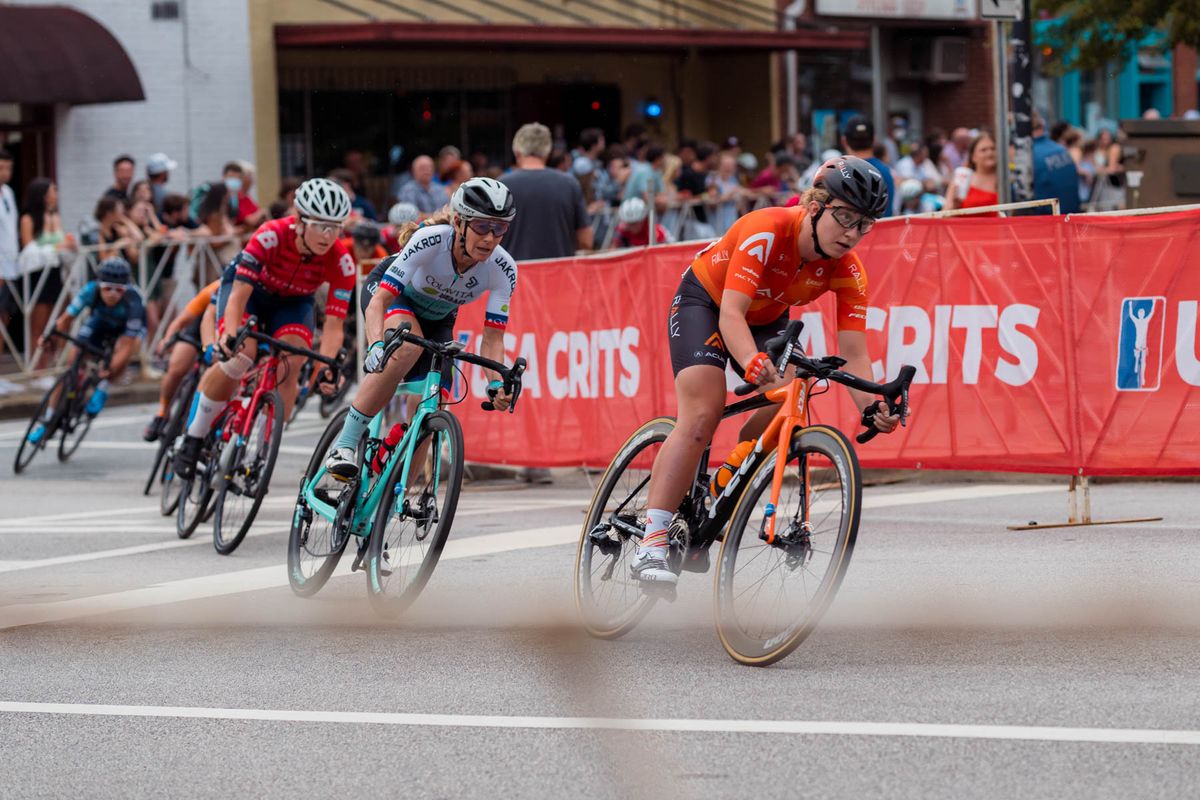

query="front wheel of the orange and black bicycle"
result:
[714,426,863,667]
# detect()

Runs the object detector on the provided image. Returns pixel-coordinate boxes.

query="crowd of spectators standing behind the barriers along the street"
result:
[0,107,1142,388]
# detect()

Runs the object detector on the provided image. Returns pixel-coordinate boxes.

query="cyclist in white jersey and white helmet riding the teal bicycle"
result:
[325,178,517,481]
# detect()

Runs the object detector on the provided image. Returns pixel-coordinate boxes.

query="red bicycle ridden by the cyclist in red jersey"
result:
[176,317,344,555]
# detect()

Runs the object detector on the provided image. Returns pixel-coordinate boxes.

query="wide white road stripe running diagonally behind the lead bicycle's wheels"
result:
[0,485,1057,630]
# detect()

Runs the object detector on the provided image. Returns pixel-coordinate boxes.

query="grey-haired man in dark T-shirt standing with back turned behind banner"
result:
[500,122,592,483]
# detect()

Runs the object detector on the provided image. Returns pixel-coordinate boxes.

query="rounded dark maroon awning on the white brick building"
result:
[0,5,145,104]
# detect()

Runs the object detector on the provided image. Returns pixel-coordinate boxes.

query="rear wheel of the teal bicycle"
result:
[288,408,353,597]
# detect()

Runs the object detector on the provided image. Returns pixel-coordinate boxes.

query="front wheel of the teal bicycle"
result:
[367,411,463,616]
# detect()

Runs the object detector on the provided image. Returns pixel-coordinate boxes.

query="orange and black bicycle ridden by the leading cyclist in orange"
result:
[575,320,916,666]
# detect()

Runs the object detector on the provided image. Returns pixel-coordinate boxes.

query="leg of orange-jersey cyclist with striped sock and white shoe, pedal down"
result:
[634,365,726,583]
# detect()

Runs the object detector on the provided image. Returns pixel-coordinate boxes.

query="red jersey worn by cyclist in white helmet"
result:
[236,217,355,318]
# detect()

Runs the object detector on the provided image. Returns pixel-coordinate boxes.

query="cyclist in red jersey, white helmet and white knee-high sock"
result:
[175,178,356,480]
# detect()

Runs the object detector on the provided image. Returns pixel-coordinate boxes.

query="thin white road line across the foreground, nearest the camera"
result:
[0,700,1200,745]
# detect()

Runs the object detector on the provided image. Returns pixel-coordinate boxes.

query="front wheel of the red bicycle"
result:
[212,391,283,555]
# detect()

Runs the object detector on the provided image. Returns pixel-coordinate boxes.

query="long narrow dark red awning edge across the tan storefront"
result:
[275,22,869,52]
